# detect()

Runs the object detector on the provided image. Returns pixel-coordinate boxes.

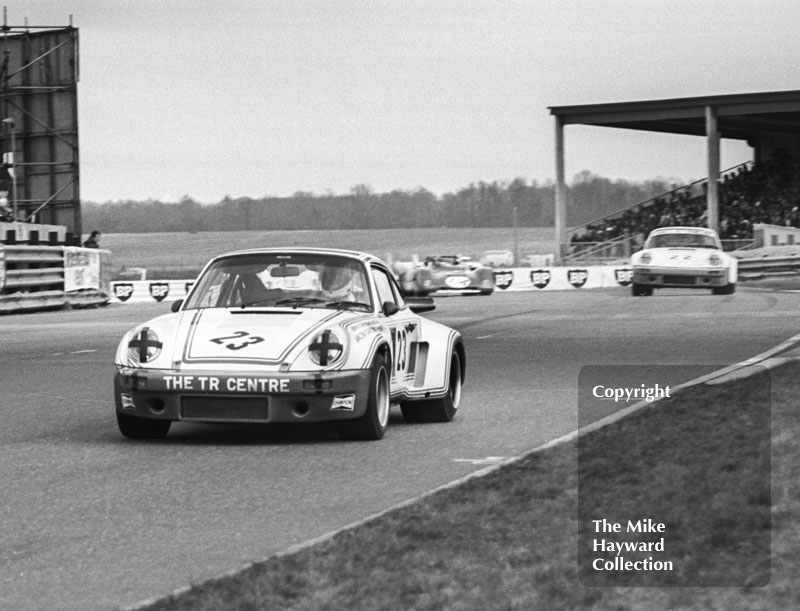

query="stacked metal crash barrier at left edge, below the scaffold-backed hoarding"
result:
[0,244,109,314]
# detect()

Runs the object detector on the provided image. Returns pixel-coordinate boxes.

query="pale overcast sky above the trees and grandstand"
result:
[3,0,800,202]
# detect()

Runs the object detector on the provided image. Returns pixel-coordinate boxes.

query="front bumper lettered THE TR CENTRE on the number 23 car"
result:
[114,368,370,423]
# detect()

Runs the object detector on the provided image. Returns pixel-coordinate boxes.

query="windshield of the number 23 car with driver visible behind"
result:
[184,253,372,309]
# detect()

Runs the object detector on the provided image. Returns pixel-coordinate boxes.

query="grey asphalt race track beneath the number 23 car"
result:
[0,289,800,611]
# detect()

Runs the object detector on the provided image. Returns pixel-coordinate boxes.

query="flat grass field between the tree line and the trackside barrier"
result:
[102,227,555,279]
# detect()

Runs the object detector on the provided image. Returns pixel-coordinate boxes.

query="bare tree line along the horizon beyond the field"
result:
[82,171,673,233]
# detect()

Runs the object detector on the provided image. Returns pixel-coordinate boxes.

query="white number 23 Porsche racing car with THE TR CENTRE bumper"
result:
[114,248,466,439]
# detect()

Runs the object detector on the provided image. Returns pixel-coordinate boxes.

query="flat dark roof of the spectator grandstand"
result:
[550,90,800,140]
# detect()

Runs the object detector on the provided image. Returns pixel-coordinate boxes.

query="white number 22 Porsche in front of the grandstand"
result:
[631,227,739,297]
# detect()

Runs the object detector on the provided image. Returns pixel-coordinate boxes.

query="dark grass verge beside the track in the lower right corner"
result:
[136,362,800,611]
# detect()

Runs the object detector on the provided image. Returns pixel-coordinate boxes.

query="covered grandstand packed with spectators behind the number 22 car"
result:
[550,91,800,262]
